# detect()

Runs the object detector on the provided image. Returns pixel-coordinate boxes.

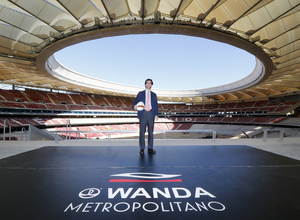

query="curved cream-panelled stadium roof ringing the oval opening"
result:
[0,0,300,103]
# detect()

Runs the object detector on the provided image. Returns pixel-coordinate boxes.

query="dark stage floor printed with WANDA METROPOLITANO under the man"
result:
[0,146,300,220]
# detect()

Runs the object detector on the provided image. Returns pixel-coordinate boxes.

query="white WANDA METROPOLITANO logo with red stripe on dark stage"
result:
[64,172,226,214]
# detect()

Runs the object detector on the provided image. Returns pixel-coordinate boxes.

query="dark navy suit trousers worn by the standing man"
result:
[140,111,154,150]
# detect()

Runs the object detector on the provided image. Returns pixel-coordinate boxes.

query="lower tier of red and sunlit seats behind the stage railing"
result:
[0,113,300,140]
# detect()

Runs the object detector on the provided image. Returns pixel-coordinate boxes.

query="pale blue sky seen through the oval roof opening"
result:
[54,34,255,90]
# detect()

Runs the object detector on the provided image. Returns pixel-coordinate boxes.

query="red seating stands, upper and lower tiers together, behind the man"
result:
[0,90,300,138]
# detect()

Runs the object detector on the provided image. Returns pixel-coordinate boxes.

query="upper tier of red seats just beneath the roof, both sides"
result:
[0,90,298,113]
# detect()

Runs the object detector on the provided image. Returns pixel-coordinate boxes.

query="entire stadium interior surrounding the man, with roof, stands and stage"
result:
[0,0,300,219]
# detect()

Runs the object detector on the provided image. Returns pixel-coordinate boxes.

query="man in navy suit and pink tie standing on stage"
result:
[133,79,158,155]
